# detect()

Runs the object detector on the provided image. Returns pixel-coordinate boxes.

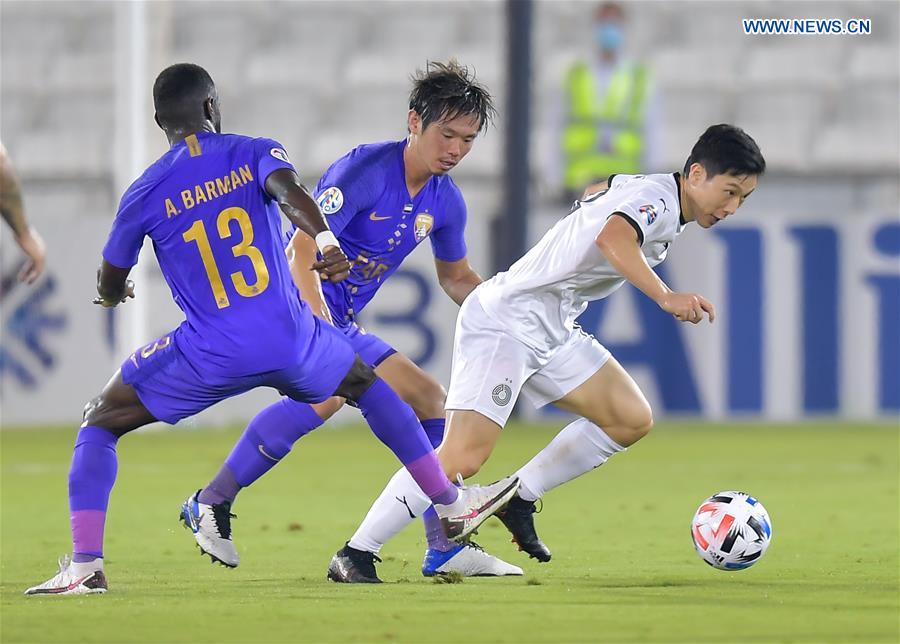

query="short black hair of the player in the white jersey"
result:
[684,123,766,179]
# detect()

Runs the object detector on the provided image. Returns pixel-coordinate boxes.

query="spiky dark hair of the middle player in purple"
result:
[409,59,497,132]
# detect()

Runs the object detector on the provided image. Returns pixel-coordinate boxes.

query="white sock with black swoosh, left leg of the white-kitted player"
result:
[350,468,431,554]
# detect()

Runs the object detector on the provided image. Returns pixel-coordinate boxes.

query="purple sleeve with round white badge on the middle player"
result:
[314,149,383,236]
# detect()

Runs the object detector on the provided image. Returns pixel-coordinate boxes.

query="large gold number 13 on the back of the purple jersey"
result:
[182,207,269,309]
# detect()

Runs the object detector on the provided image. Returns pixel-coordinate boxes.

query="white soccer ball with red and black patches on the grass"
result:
[691,492,772,570]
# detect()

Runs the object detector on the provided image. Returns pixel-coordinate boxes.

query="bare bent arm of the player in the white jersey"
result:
[595,213,716,324]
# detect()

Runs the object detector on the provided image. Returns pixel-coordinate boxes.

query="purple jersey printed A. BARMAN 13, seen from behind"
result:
[103,132,312,376]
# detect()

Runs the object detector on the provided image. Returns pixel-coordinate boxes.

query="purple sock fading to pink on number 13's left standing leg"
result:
[69,425,119,562]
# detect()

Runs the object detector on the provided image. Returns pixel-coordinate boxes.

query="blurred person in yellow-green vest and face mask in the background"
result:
[553,2,662,199]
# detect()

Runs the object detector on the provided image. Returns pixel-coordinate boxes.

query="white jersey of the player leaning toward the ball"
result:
[475,174,684,355]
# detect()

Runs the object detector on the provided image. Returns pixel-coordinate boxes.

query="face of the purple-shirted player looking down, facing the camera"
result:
[408,111,481,175]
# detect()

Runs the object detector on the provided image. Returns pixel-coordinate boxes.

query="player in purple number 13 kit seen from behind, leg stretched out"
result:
[26,64,517,595]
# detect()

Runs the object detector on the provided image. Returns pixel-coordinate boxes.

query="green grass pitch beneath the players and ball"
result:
[0,424,900,643]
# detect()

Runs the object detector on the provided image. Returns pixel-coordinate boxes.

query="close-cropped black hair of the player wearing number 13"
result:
[153,63,216,127]
